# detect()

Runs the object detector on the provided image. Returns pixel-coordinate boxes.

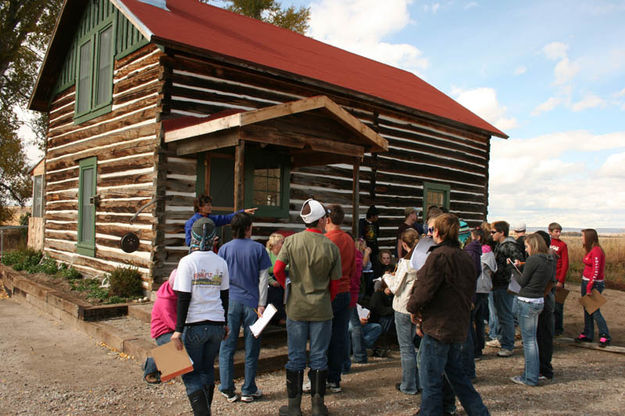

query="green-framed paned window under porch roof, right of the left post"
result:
[245,150,291,217]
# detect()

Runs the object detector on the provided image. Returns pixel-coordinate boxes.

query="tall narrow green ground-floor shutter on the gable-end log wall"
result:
[76,157,97,257]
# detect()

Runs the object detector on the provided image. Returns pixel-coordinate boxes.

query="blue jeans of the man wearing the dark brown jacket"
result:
[419,334,489,416]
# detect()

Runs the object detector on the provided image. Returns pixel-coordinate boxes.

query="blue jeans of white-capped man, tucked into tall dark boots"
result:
[286,317,332,371]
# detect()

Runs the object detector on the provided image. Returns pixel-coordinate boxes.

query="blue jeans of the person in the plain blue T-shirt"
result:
[219,299,260,394]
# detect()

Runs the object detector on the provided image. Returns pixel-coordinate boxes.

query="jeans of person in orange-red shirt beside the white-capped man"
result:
[328,292,350,383]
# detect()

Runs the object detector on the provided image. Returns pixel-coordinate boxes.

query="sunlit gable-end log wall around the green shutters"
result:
[44,45,162,288]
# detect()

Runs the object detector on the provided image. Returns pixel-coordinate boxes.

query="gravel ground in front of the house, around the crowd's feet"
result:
[0,282,625,416]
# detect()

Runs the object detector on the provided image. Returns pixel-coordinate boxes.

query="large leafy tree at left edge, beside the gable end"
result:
[0,0,62,223]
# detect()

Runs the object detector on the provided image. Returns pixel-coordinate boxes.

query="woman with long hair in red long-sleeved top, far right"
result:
[575,229,610,347]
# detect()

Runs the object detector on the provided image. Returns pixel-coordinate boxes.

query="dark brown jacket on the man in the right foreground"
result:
[407,242,476,344]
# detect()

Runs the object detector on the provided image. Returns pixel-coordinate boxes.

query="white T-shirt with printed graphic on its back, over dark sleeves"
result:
[174,251,230,324]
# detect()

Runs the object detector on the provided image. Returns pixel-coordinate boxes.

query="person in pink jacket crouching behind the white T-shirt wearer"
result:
[143,269,178,384]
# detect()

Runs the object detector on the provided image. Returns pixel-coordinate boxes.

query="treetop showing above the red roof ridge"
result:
[213,0,310,34]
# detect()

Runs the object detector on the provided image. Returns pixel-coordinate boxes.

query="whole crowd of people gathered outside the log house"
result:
[144,196,610,416]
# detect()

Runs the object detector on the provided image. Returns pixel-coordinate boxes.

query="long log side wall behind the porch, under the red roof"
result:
[154,54,490,280]
